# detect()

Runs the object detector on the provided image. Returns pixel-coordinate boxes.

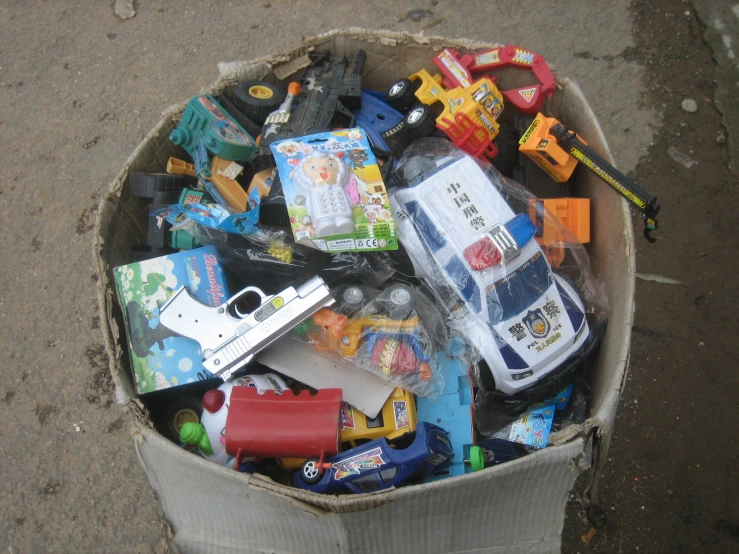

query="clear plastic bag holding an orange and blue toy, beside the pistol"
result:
[298,283,447,398]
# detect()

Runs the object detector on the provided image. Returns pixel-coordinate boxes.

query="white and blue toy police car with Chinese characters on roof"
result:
[391,156,589,395]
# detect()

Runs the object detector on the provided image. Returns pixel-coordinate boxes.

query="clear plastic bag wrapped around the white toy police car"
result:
[390,138,608,428]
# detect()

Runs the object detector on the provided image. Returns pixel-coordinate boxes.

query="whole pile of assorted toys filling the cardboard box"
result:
[114,45,659,494]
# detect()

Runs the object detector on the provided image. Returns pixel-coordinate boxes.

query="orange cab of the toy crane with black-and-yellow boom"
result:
[518,113,586,183]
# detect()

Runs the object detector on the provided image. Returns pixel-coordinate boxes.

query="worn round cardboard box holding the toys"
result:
[94,28,635,554]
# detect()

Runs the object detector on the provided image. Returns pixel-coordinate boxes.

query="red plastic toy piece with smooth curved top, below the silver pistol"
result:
[225,387,341,467]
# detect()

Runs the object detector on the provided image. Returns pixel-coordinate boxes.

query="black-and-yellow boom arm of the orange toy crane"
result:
[550,123,660,242]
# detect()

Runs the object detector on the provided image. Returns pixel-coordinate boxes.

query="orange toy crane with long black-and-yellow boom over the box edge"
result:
[519,113,660,242]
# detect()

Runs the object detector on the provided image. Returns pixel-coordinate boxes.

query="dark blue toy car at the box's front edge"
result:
[293,423,454,494]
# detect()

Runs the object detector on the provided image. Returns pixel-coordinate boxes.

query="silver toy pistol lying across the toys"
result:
[159,276,334,381]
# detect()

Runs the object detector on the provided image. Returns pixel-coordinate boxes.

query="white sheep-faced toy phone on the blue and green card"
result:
[293,152,359,238]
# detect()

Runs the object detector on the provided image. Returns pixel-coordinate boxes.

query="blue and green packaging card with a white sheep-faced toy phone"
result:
[270,128,398,252]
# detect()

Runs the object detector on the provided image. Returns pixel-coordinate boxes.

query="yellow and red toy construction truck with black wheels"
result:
[386,49,503,159]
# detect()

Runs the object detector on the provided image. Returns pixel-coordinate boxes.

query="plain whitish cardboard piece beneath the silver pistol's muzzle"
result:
[256,337,394,418]
